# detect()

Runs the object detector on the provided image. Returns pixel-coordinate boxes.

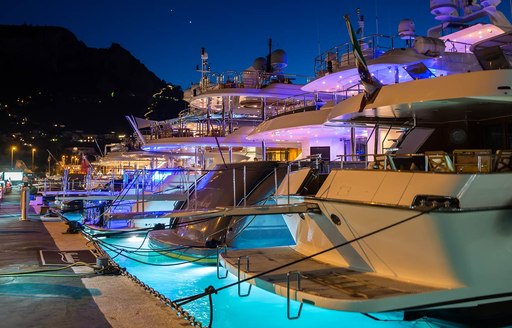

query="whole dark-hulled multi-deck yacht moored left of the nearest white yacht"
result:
[123,43,323,264]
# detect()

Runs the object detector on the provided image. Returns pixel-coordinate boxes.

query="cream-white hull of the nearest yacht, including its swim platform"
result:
[225,170,512,312]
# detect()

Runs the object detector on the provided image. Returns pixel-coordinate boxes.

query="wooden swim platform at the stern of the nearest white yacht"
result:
[222,247,441,312]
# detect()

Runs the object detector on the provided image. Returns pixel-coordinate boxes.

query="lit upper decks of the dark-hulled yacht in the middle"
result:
[132,48,317,169]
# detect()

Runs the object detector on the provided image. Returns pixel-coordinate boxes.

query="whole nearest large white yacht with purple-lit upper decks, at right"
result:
[221,0,512,326]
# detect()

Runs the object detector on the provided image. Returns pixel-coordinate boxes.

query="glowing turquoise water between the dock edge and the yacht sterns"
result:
[97,236,444,328]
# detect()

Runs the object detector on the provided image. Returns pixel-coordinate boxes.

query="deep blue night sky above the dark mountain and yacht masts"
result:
[0,0,510,89]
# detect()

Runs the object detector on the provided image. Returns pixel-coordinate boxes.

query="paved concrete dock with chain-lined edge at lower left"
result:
[0,189,191,328]
